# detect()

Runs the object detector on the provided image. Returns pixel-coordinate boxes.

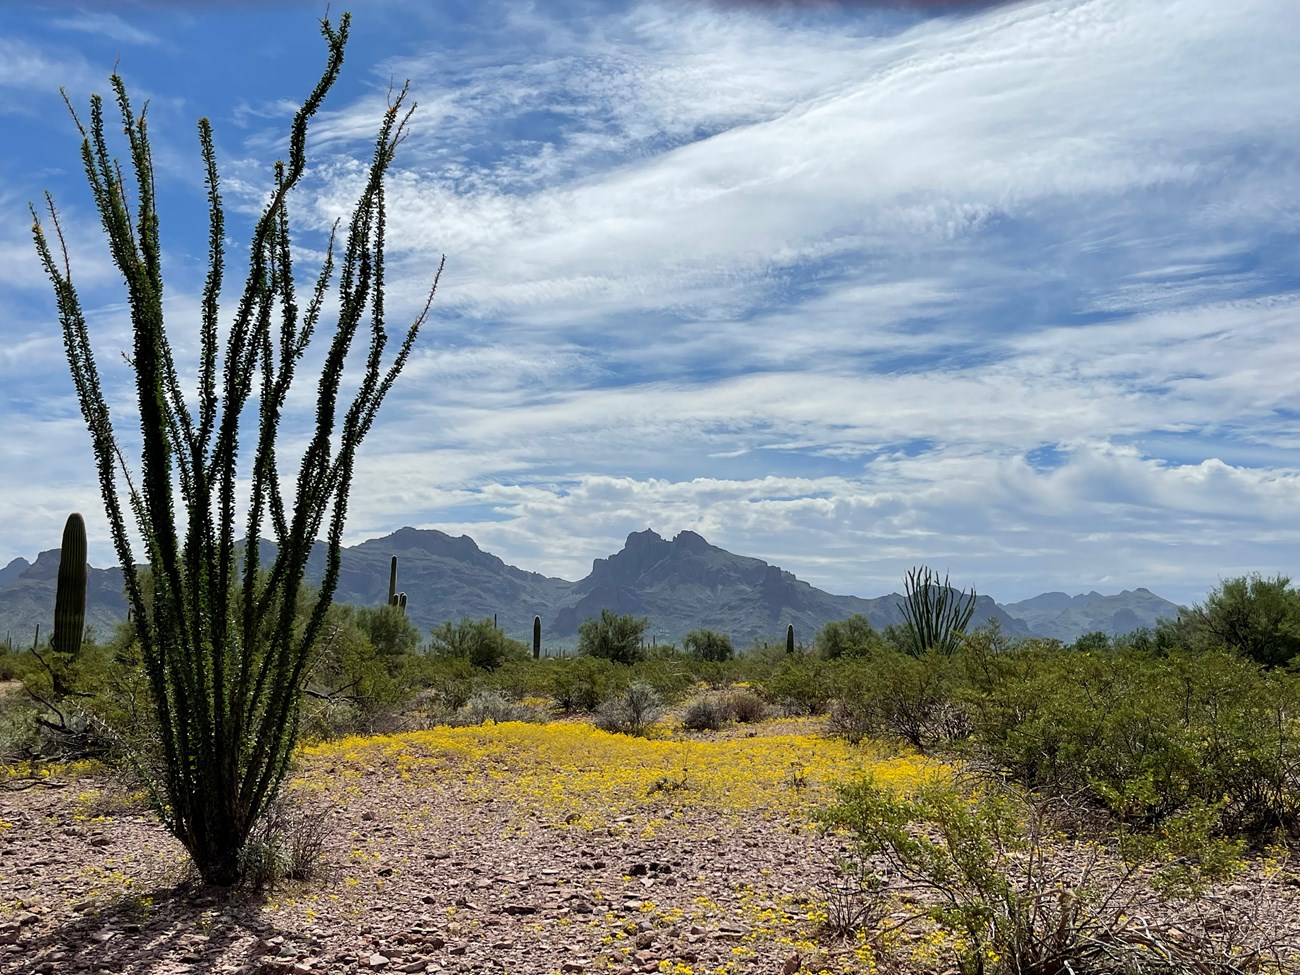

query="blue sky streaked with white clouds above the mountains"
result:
[0,0,1300,603]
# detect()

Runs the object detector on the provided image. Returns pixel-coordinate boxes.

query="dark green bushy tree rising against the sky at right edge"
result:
[1180,573,1300,667]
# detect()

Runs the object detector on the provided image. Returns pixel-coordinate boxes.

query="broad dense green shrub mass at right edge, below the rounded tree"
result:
[962,647,1300,836]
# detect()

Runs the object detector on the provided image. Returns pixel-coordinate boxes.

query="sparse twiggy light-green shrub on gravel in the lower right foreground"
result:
[820,780,1238,975]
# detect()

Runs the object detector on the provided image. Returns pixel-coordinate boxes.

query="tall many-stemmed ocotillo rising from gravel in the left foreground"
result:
[25,14,441,885]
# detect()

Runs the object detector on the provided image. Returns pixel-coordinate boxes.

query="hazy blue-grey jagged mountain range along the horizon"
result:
[0,528,1179,647]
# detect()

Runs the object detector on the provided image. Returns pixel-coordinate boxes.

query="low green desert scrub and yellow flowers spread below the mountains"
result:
[0,580,1300,972]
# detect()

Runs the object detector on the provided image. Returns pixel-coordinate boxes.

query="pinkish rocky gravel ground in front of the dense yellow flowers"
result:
[0,733,1300,975]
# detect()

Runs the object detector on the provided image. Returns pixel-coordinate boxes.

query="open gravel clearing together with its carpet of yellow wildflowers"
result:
[0,719,949,975]
